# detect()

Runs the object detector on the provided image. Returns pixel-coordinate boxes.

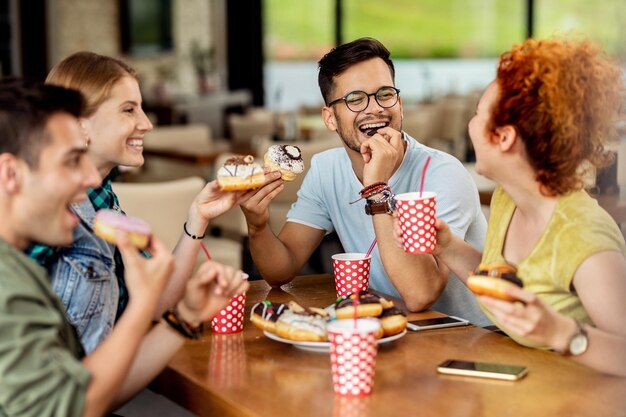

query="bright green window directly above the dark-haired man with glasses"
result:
[343,0,526,59]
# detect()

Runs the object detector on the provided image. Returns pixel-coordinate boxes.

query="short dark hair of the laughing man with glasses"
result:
[317,38,396,104]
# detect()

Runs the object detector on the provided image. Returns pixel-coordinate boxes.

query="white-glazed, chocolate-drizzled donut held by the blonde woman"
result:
[217,155,265,191]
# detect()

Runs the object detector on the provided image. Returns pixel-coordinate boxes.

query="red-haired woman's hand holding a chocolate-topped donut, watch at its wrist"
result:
[479,285,576,351]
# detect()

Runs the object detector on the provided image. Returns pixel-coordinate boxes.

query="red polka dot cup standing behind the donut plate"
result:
[332,253,372,297]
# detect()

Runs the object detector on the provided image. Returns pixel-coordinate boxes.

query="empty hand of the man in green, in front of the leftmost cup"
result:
[178,261,249,325]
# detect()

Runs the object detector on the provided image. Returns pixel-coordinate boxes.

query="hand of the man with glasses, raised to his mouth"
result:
[361,127,404,185]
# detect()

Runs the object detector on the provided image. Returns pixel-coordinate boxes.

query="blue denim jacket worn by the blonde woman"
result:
[50,200,119,353]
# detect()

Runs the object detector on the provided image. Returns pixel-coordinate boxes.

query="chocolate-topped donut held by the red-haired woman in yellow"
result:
[467,263,524,301]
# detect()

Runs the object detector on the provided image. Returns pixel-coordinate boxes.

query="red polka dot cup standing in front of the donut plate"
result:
[327,319,380,397]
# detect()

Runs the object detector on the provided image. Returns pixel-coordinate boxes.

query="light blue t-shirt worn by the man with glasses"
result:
[287,133,490,326]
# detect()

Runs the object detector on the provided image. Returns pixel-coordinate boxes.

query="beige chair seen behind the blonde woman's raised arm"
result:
[113,177,243,268]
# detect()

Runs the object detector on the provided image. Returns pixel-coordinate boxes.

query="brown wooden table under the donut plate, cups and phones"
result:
[153,275,626,417]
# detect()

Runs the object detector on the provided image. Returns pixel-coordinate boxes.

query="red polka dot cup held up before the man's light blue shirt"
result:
[395,192,437,253]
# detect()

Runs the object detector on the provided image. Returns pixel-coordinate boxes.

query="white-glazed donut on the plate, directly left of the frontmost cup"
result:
[276,302,328,342]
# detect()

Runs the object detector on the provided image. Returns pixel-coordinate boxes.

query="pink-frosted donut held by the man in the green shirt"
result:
[93,209,152,249]
